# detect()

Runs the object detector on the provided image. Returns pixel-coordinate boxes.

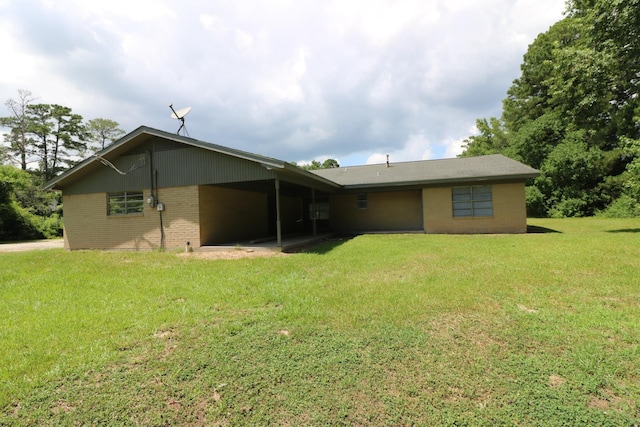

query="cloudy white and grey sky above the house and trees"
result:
[0,0,565,166]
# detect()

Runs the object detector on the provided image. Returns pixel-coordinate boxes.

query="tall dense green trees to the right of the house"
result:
[462,0,640,217]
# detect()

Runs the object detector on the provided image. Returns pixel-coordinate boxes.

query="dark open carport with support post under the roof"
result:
[200,165,337,249]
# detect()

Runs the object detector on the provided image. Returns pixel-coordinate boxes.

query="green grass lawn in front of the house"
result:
[0,219,640,426]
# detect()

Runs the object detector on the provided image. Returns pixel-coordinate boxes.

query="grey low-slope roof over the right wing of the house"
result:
[313,154,540,188]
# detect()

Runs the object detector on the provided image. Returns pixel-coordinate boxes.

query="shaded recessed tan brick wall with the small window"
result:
[330,190,422,232]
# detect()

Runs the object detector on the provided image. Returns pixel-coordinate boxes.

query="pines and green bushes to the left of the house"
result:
[0,90,125,241]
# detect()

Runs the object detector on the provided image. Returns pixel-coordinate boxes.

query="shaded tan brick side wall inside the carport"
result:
[199,186,269,245]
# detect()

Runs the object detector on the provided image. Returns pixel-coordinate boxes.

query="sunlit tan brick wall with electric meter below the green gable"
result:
[63,186,200,250]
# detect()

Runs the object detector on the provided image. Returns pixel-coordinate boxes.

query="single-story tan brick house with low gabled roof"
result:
[45,126,538,250]
